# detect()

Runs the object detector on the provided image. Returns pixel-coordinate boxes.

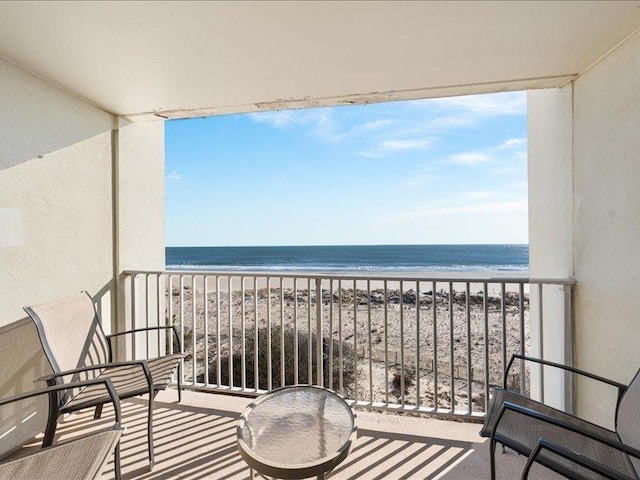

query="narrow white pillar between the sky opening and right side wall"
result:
[528,85,573,407]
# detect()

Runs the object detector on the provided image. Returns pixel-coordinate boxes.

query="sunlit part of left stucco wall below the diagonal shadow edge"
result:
[0,132,113,318]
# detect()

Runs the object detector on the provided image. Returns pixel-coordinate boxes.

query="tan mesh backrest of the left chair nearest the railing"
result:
[25,292,109,378]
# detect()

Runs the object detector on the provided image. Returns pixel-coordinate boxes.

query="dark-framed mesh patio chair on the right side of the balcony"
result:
[480,354,640,480]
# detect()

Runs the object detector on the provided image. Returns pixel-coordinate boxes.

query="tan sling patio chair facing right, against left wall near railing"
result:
[25,292,183,468]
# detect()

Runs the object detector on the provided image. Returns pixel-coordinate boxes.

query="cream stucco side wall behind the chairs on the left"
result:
[0,61,113,451]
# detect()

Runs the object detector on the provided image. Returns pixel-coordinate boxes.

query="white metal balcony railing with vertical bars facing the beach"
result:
[121,271,574,417]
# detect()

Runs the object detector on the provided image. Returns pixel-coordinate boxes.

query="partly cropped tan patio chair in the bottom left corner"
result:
[0,378,124,480]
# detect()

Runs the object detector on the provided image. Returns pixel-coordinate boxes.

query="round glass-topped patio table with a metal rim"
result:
[237,385,357,479]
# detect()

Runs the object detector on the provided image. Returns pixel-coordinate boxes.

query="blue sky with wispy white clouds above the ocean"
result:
[165,92,528,246]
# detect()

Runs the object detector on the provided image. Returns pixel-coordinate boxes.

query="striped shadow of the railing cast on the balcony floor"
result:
[25,391,488,480]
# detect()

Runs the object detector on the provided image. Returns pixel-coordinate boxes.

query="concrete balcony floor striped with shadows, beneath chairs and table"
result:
[11,390,559,480]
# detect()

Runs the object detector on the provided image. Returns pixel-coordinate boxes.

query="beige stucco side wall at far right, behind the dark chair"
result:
[573,31,640,426]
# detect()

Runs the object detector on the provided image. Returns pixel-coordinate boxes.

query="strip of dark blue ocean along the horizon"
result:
[165,245,529,273]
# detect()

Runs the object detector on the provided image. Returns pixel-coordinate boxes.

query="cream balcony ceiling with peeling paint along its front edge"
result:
[0,0,640,119]
